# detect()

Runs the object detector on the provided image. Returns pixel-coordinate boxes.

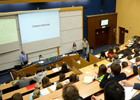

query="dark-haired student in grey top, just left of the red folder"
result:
[13,72,32,88]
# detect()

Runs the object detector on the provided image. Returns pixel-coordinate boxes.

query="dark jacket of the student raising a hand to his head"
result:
[100,73,127,88]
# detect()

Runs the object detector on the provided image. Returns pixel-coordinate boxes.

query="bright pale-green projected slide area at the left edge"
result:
[0,18,18,45]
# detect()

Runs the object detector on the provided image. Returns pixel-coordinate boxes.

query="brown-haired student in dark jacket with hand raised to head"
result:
[100,62,127,88]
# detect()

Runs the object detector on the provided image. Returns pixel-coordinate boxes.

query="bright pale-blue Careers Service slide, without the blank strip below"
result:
[18,10,60,43]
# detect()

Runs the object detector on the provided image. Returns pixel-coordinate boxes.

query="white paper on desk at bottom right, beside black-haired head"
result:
[124,86,137,100]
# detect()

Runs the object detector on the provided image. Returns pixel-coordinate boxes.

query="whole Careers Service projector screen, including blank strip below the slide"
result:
[18,10,61,53]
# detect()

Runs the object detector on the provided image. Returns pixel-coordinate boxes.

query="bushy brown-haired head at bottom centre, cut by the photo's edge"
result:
[62,84,79,100]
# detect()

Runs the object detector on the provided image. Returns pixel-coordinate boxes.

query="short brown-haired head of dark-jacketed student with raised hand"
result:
[110,62,121,76]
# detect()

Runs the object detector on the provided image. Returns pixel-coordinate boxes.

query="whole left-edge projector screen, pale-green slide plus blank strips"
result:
[0,16,19,54]
